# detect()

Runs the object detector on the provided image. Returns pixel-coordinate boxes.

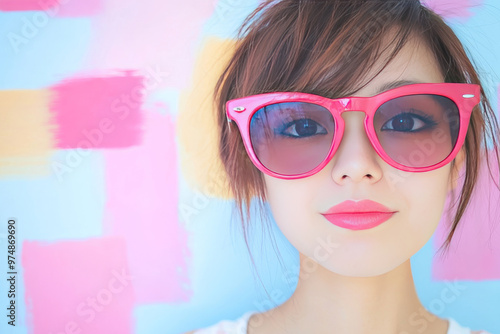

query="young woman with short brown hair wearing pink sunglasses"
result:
[186,0,500,334]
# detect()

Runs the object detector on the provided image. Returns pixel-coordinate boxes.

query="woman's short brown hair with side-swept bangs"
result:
[215,0,500,261]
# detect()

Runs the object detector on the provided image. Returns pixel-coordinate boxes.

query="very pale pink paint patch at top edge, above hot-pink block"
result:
[86,0,216,89]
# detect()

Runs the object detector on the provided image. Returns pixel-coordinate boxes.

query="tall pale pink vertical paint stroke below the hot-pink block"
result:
[104,112,191,303]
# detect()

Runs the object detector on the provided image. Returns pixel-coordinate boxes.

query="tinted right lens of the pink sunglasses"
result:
[373,94,460,167]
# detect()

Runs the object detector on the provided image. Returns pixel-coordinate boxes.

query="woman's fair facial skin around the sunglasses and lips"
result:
[264,38,462,277]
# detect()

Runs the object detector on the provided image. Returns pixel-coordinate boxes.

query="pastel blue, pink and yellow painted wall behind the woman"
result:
[0,0,500,334]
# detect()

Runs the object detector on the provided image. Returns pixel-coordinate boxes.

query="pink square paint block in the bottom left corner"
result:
[22,238,135,334]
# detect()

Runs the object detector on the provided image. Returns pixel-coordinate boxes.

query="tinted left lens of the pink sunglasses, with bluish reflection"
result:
[250,102,335,176]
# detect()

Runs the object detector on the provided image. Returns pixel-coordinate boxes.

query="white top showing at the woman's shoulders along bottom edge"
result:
[194,311,490,334]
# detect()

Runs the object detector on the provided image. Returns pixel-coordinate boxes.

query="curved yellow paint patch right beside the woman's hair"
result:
[177,37,235,199]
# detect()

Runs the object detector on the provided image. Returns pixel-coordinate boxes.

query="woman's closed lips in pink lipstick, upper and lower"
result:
[322,200,397,230]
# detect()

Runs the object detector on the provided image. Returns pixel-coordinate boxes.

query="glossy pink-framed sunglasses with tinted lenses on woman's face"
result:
[226,83,480,179]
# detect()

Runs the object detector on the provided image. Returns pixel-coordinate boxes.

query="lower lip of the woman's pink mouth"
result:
[323,212,395,230]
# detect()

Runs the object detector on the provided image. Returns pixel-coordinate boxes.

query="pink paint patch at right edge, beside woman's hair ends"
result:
[432,151,500,280]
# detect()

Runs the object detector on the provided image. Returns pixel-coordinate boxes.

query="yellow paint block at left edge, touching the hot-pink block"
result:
[0,90,55,176]
